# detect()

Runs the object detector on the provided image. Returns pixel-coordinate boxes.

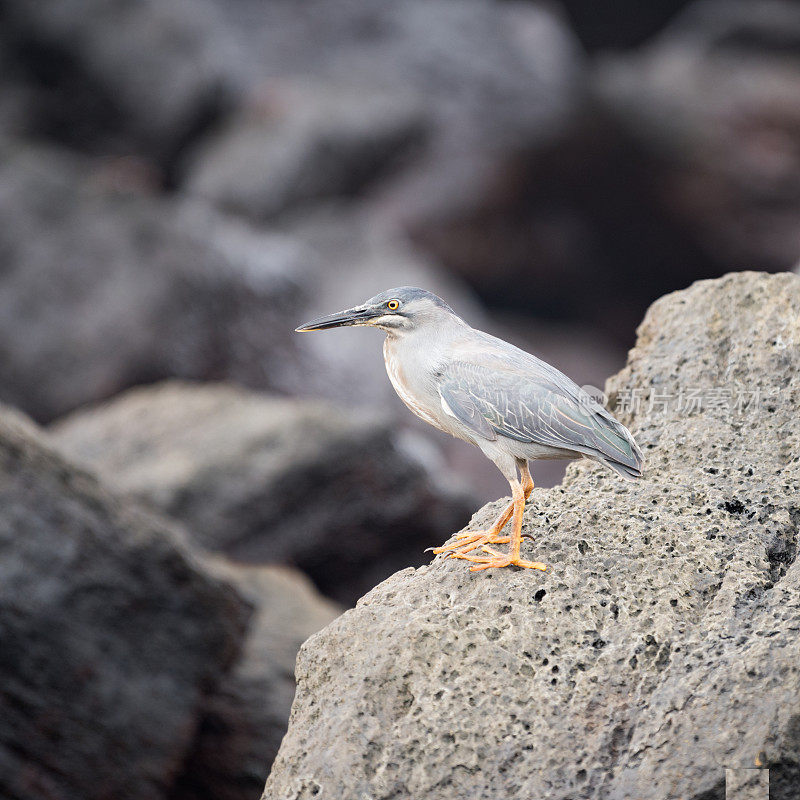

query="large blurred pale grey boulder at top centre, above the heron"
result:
[189,0,582,226]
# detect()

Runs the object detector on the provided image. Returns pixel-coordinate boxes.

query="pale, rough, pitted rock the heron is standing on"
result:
[264,273,800,800]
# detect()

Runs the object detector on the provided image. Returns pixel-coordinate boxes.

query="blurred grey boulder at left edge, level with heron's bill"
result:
[0,144,308,420]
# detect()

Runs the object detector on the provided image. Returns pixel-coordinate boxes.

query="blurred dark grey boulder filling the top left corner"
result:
[0,0,240,167]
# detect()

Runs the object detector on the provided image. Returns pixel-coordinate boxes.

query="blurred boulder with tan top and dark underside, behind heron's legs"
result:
[51,382,476,603]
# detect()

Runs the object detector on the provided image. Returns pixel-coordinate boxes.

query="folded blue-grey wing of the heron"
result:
[439,361,640,468]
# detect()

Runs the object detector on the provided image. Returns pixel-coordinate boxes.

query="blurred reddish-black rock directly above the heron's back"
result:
[400,114,724,352]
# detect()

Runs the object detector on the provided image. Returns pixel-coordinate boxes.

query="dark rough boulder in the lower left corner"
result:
[0,410,249,800]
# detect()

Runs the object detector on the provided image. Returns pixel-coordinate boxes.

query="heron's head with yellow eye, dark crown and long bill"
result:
[295,286,458,335]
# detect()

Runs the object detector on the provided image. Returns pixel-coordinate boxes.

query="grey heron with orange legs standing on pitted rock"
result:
[297,286,643,570]
